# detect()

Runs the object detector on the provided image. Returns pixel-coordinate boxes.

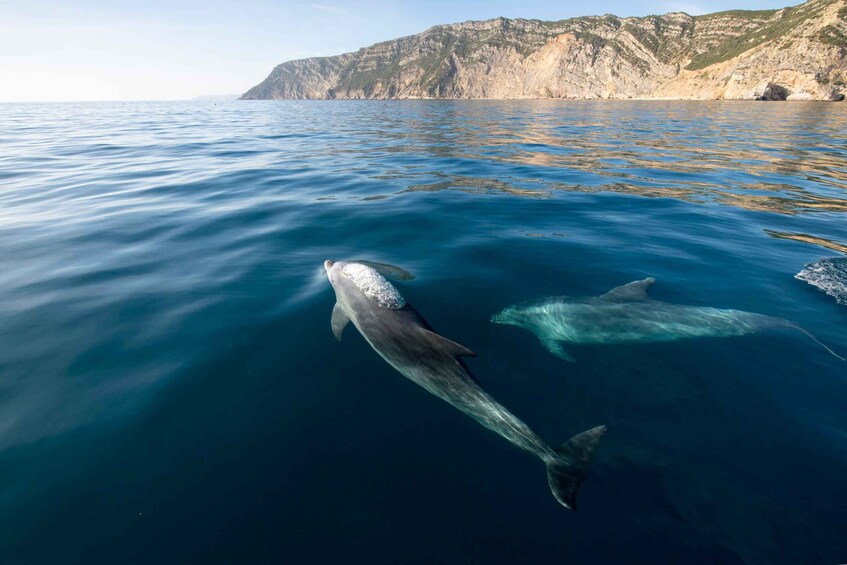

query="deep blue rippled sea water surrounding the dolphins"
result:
[0,101,847,564]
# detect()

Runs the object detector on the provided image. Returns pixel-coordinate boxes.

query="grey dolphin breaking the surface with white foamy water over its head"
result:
[324,261,606,510]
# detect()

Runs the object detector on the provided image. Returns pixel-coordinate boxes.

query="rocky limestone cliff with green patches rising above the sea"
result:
[242,0,847,100]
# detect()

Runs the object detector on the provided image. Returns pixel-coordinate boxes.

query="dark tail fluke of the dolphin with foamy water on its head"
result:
[547,426,606,510]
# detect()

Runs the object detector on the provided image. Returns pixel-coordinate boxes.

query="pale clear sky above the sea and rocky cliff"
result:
[0,0,798,101]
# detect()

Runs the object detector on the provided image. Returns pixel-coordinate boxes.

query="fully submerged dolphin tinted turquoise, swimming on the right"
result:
[491,278,844,361]
